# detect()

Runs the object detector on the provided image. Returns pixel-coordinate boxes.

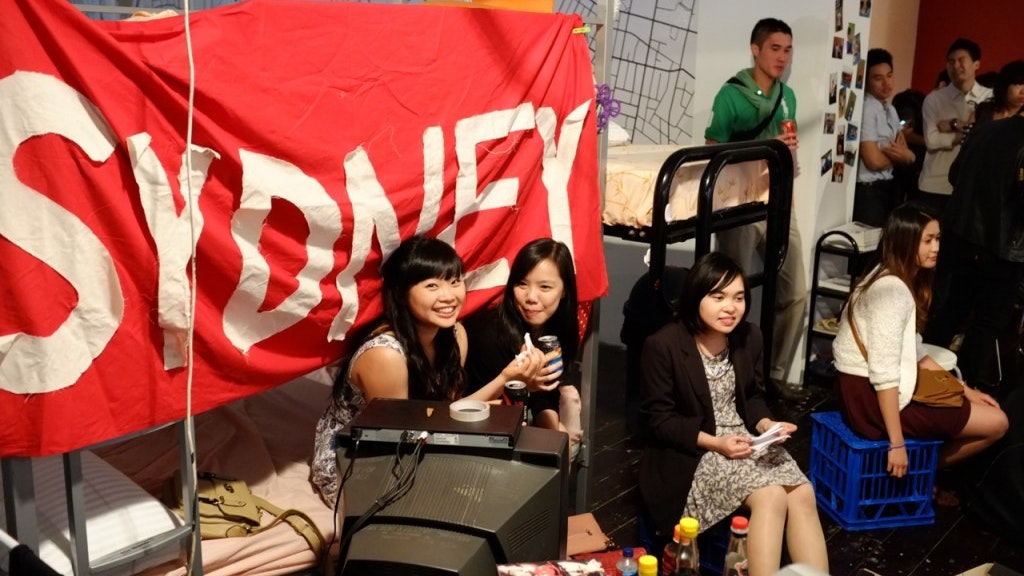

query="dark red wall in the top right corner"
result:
[912,0,1024,94]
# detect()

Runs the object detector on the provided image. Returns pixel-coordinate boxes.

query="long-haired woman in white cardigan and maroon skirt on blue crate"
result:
[833,204,1009,478]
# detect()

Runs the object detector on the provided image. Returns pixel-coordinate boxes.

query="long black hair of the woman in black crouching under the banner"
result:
[498,238,580,362]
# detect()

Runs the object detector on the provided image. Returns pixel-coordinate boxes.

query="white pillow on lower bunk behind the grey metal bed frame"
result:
[0,450,182,576]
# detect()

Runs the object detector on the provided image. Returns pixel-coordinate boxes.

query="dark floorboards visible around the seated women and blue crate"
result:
[590,344,1024,576]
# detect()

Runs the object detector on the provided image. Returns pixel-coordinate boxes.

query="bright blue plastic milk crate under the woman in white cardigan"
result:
[810,412,942,530]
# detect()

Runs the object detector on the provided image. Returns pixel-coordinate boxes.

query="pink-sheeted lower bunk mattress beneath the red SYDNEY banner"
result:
[97,370,337,576]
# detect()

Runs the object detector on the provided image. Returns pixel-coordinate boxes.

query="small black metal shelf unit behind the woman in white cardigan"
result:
[804,231,877,385]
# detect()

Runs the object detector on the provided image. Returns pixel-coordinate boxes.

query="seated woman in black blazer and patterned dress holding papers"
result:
[640,252,828,576]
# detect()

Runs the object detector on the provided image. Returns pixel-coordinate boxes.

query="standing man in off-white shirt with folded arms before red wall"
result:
[916,38,992,216]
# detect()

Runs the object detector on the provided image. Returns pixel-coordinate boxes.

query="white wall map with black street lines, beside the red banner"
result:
[555,0,697,143]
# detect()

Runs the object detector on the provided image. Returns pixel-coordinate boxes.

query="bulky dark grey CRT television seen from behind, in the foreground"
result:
[338,407,568,576]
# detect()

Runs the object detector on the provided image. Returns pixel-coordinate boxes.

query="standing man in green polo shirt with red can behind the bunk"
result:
[705,18,807,400]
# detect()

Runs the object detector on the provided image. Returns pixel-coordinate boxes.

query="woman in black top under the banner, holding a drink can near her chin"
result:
[465,238,583,441]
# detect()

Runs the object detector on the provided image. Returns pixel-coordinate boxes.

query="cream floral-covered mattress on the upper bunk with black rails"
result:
[602,145,768,228]
